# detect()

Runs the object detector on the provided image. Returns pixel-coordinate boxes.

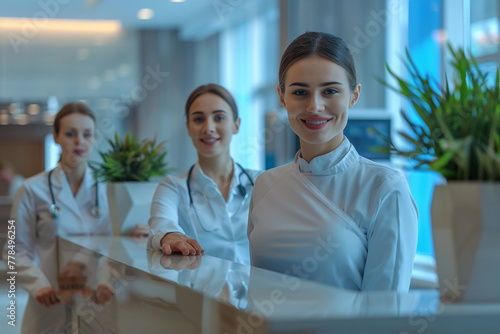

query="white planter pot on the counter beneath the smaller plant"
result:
[107,182,158,236]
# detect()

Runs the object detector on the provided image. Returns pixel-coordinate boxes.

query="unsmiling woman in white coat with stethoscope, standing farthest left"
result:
[4,103,111,333]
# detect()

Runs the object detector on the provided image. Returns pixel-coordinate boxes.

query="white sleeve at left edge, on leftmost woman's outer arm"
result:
[3,185,51,296]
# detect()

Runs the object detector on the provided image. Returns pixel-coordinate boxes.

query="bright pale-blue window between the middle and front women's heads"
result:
[220,1,279,169]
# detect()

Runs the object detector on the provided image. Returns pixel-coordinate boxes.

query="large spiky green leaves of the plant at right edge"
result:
[377,46,500,181]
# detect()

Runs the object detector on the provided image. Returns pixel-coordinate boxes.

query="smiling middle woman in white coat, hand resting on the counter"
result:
[149,84,258,264]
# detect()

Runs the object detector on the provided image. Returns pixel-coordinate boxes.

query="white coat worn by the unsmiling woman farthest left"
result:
[4,165,112,333]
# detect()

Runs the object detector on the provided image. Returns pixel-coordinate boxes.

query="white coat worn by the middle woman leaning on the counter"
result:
[148,163,259,264]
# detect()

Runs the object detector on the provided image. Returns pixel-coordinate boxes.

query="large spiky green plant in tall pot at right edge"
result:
[382,46,500,301]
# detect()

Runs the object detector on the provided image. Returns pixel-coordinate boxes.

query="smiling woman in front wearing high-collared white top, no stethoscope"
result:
[248,32,418,291]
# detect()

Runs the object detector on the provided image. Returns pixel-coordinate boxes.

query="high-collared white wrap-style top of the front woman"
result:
[248,138,418,291]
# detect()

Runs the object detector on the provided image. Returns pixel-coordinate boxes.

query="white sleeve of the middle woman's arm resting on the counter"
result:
[148,177,186,250]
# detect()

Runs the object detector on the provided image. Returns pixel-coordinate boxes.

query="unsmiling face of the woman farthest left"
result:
[53,113,95,168]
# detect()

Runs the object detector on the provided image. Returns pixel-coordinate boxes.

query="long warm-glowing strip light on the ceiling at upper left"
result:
[0,17,121,33]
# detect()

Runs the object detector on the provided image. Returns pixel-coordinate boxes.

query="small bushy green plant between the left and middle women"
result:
[94,131,170,182]
